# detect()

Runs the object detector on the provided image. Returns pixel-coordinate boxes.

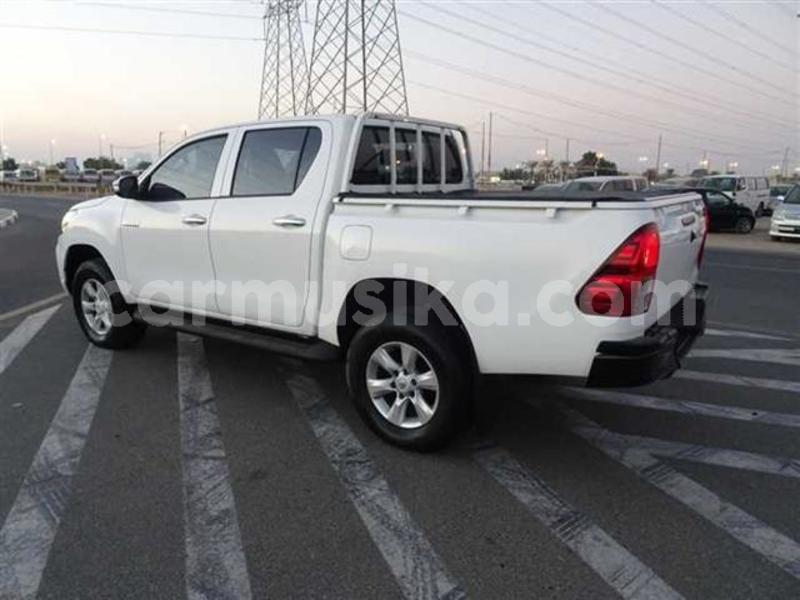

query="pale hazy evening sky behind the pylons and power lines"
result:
[0,0,800,174]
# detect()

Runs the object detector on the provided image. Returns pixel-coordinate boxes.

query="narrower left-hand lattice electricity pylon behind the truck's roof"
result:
[258,0,308,119]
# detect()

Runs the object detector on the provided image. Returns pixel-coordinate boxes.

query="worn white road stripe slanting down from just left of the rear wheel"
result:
[286,370,465,600]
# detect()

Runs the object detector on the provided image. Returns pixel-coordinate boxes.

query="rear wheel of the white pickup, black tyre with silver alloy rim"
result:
[346,317,472,450]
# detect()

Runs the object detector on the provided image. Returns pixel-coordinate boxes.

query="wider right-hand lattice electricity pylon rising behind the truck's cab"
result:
[305,0,408,114]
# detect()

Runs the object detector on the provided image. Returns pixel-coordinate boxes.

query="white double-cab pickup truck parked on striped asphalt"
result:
[56,114,707,448]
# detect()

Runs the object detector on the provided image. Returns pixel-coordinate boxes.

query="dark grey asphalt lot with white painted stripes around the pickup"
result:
[0,198,800,600]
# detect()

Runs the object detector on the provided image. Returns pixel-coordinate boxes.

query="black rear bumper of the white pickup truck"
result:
[586,283,708,387]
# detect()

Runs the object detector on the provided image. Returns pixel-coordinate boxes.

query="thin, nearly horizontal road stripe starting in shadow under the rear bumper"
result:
[565,388,800,427]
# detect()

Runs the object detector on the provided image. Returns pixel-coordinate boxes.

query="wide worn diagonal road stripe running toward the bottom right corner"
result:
[552,403,800,579]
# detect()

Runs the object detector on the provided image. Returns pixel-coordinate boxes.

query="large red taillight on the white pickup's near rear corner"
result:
[576,223,661,317]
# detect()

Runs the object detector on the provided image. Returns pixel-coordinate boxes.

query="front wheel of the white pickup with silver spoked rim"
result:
[70,259,145,350]
